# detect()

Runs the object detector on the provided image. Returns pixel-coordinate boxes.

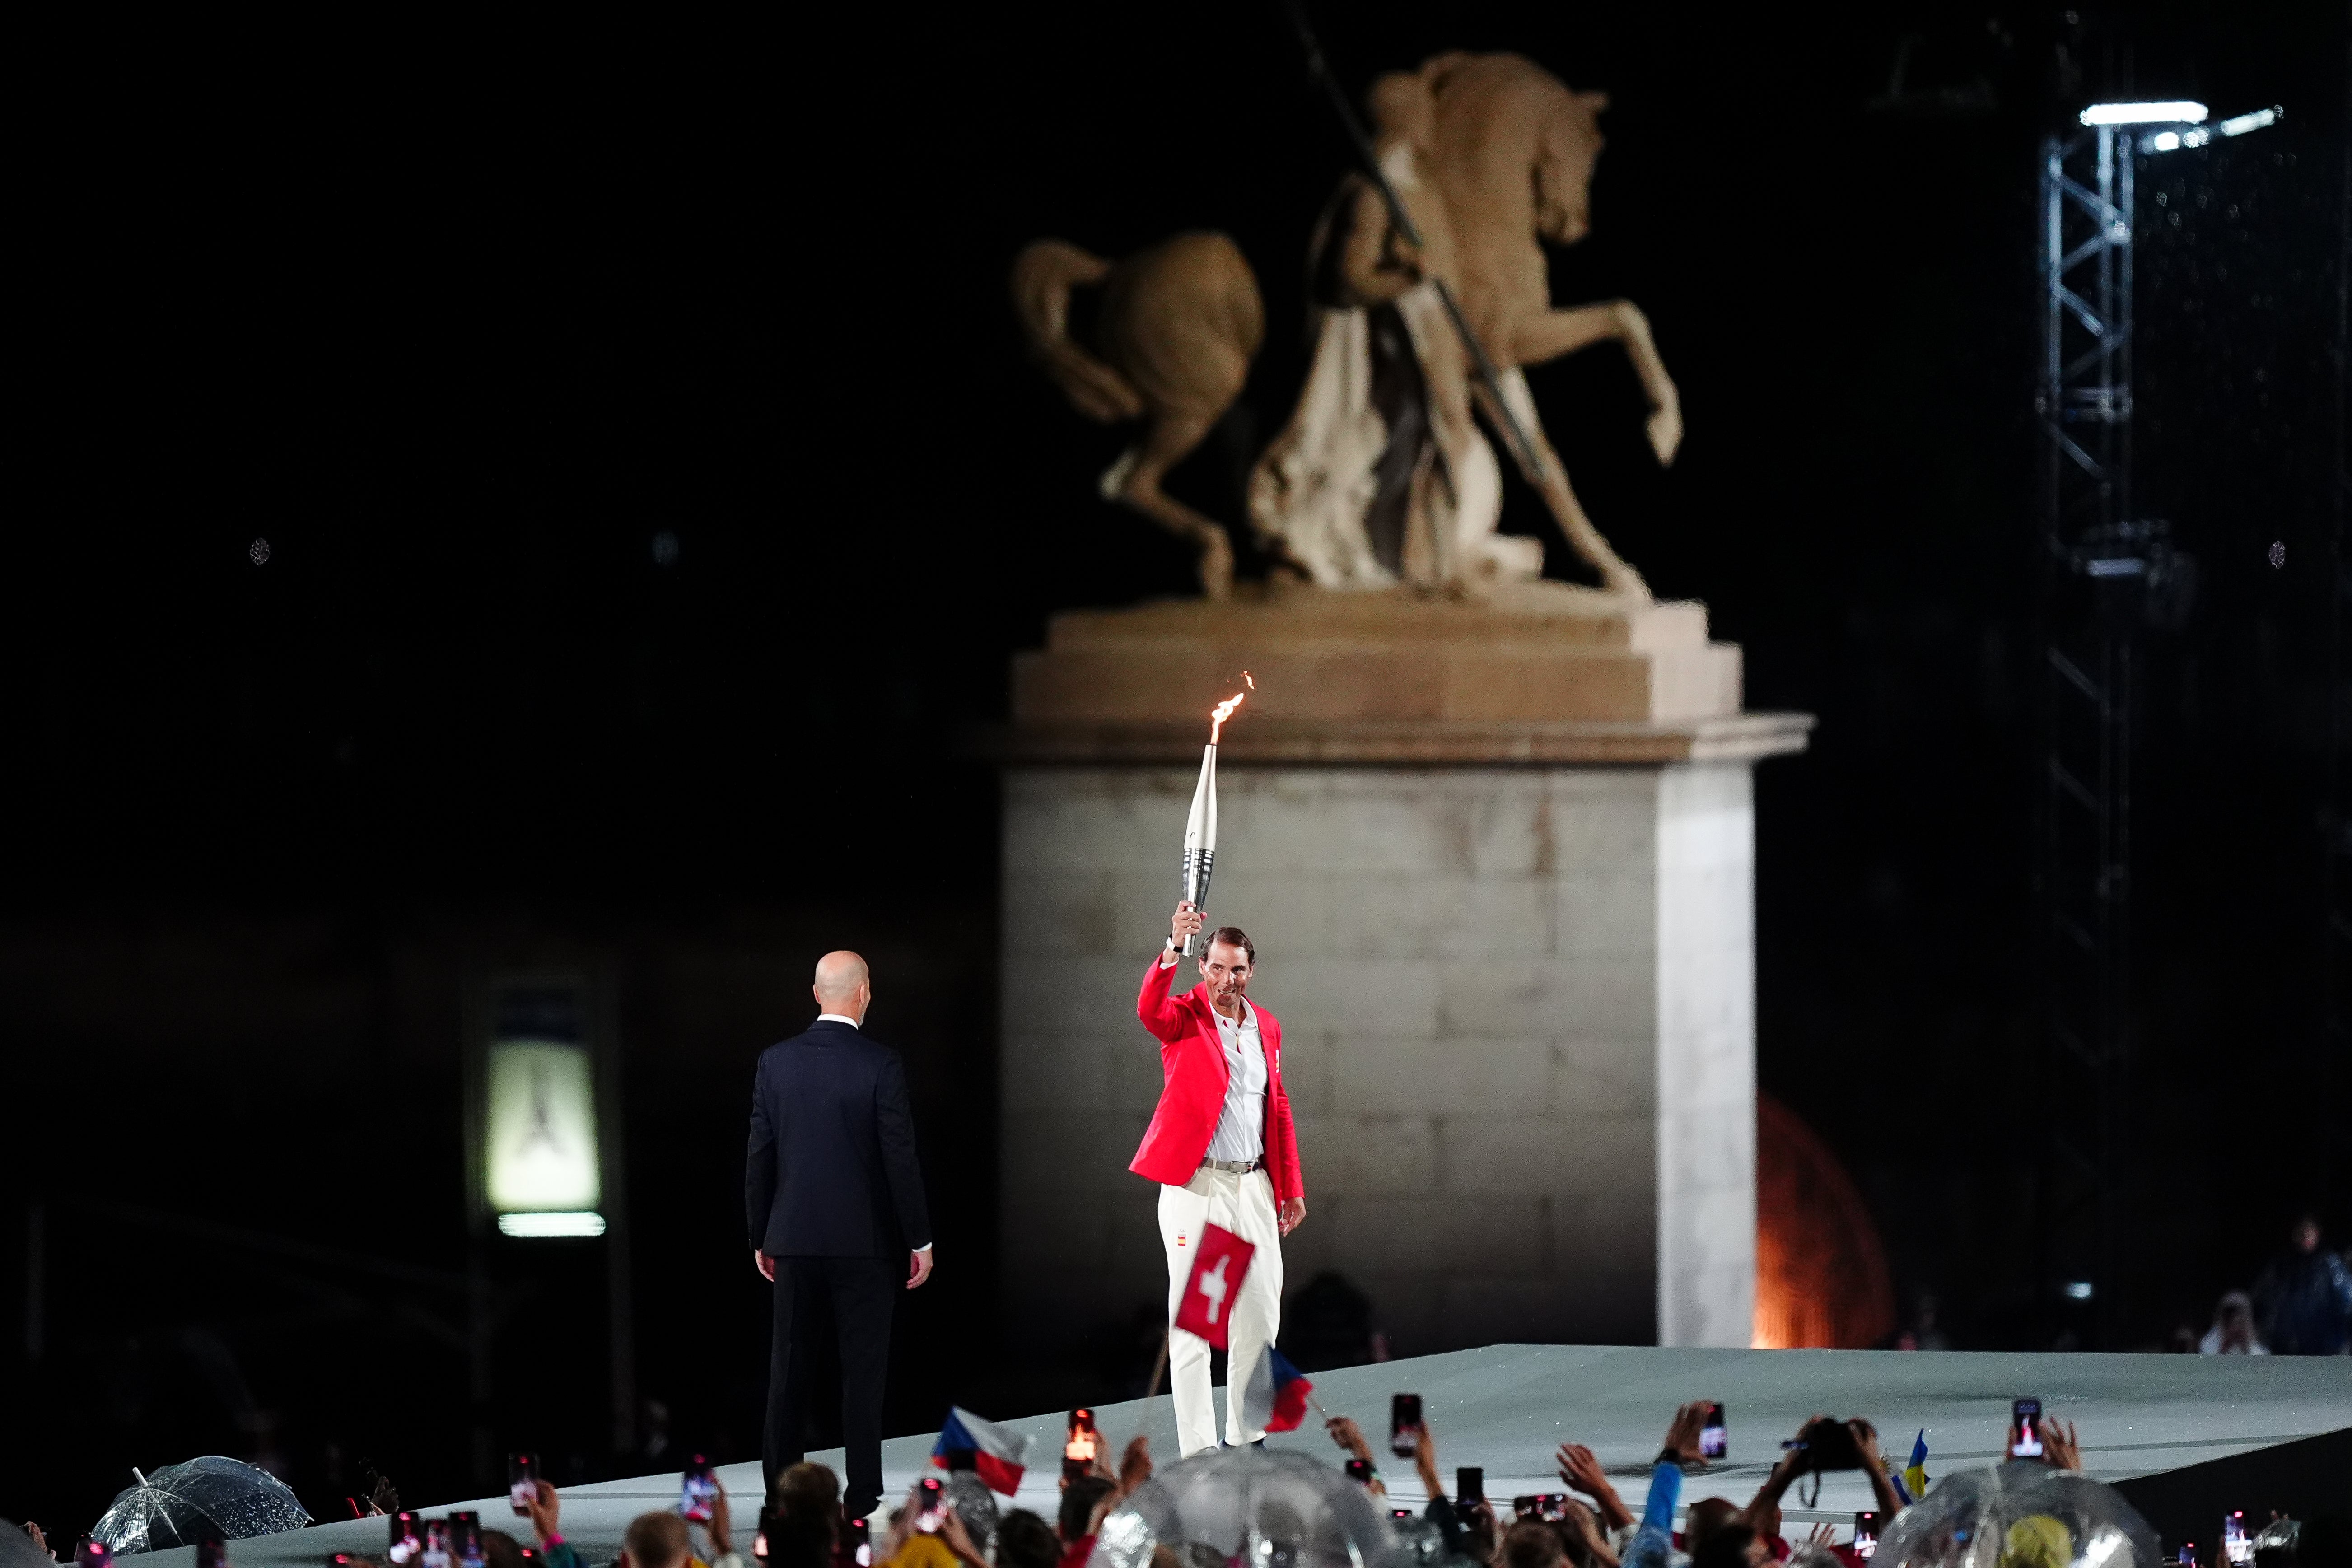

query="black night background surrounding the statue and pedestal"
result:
[0,5,2352,1540]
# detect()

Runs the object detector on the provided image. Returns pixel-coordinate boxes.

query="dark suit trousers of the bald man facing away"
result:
[760,1253,905,1519]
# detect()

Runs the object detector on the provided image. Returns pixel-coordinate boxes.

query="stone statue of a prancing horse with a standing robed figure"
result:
[1014,54,1682,599]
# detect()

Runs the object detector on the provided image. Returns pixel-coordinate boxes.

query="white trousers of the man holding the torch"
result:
[1160,1168,1282,1457]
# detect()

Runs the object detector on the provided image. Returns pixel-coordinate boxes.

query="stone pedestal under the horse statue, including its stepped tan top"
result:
[999,585,1809,1354]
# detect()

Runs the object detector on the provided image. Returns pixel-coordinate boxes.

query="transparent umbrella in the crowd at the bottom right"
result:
[1870,1462,2164,1568]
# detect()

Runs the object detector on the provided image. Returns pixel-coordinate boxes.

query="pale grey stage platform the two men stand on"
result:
[139,1344,2352,1568]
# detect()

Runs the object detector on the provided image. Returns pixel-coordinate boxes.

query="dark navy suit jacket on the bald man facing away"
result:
[743,1018,931,1258]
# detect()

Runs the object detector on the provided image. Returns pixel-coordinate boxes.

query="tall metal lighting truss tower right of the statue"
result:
[2016,125,2145,1347]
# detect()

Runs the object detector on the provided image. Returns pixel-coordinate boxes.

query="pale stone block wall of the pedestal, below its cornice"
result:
[999,762,1755,1354]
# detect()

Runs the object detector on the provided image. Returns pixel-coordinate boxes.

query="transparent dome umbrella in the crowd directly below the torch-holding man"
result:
[1089,1448,1397,1568]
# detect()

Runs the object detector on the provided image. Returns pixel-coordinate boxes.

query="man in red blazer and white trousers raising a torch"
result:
[1127,903,1308,1455]
